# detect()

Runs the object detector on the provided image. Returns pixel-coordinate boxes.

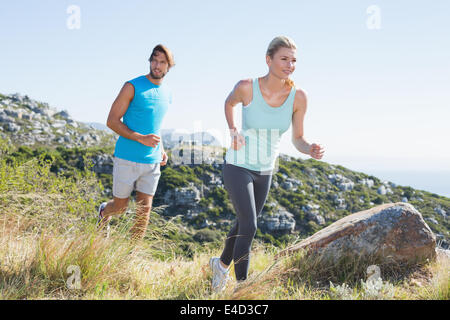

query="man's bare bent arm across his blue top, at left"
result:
[106,82,160,148]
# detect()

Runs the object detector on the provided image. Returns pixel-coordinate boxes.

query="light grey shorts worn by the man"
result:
[113,157,161,199]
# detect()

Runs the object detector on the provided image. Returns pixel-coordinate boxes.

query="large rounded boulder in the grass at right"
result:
[279,202,436,263]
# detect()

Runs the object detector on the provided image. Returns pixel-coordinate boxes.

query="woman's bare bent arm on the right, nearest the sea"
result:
[292,89,325,159]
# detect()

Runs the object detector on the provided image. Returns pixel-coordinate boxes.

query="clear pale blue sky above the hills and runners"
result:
[0,0,450,194]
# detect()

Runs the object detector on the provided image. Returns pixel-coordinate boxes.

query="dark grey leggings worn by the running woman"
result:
[220,163,272,280]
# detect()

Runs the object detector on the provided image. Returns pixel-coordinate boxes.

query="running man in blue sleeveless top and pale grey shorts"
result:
[98,44,174,240]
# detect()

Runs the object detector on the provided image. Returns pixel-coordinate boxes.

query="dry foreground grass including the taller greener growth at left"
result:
[0,155,450,300]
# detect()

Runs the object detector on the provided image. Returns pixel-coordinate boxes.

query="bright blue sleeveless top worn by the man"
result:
[114,76,172,163]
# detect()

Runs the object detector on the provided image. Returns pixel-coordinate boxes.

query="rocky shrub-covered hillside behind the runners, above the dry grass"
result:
[0,94,450,248]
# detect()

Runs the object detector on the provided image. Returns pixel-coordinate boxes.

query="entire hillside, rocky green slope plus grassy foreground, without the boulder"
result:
[0,95,450,300]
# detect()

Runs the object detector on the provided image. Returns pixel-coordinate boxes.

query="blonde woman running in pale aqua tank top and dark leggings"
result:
[210,36,324,292]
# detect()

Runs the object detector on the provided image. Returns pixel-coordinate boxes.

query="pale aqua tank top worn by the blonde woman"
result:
[225,78,295,171]
